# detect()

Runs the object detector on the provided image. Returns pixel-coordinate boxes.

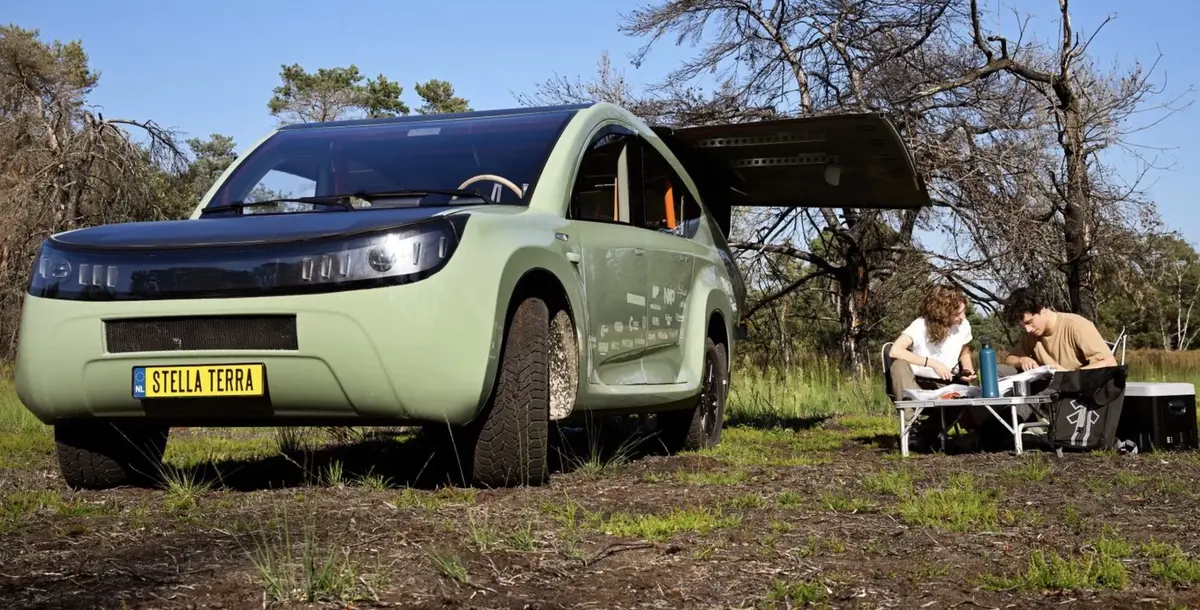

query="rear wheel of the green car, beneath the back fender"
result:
[658,339,728,453]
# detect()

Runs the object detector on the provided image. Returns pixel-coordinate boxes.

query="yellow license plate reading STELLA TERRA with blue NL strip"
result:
[133,364,266,399]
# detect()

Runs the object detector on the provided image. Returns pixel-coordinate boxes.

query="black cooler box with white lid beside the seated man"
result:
[1117,382,1196,453]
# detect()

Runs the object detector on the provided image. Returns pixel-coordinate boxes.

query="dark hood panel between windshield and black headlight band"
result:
[50,205,475,250]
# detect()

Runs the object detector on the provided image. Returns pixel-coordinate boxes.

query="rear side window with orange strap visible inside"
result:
[641,140,700,238]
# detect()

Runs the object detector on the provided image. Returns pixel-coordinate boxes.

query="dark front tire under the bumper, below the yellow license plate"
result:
[54,420,170,490]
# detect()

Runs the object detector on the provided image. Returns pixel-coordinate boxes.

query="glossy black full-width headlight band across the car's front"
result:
[29,215,467,300]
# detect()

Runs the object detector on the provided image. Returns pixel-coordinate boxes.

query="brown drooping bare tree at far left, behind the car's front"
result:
[0,26,187,358]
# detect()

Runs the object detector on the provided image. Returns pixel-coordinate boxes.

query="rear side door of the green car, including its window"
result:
[634,137,702,384]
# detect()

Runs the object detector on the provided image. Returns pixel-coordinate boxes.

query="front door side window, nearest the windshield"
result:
[571,127,636,223]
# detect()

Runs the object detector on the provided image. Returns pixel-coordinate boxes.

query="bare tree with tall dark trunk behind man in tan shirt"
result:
[914,0,1190,318]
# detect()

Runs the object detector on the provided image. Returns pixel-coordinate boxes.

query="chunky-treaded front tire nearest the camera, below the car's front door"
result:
[472,298,551,488]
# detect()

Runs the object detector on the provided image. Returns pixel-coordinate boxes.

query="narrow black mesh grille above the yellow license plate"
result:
[104,316,300,353]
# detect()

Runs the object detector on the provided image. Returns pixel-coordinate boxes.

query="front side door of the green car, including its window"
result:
[570,125,649,385]
